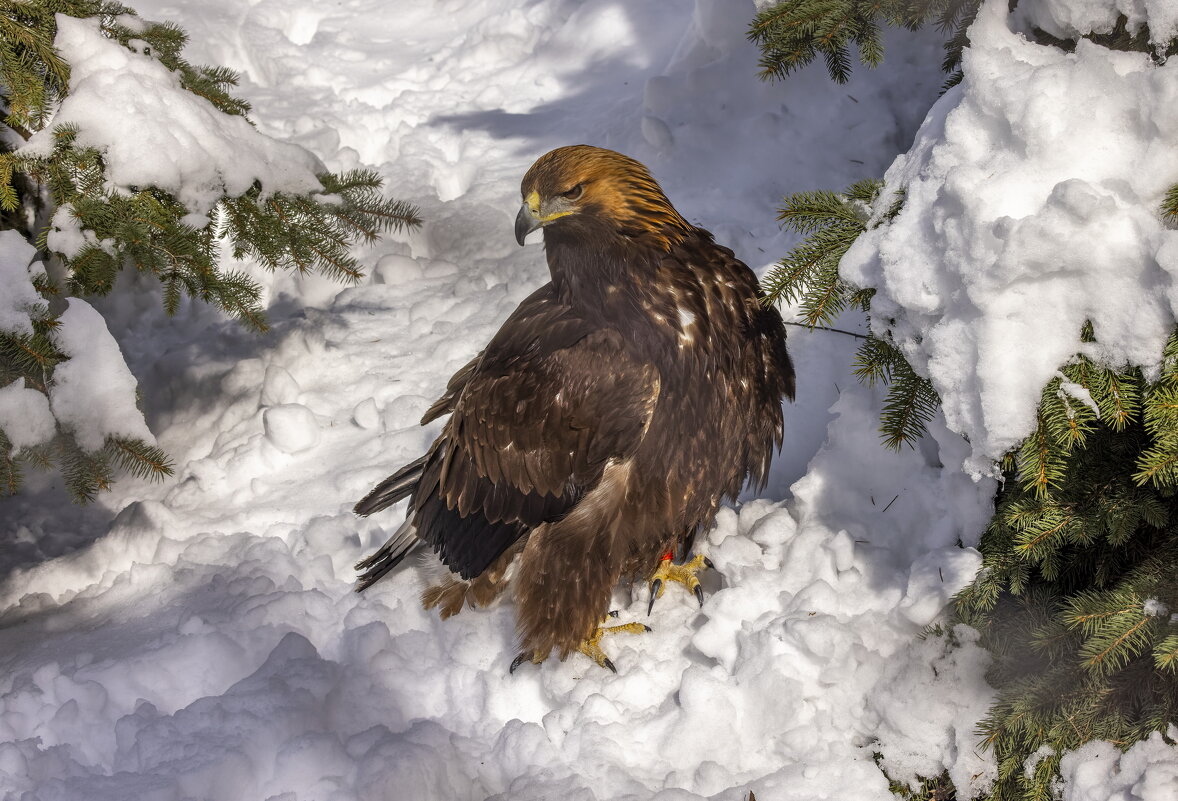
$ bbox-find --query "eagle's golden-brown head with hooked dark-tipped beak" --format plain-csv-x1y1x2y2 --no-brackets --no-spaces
515,145,695,247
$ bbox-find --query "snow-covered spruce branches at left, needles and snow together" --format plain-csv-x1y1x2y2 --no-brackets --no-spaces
0,0,421,501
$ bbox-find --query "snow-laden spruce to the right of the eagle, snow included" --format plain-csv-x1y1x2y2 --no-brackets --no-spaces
753,1,1178,801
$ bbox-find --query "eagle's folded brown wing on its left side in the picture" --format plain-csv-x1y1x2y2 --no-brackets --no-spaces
413,287,659,578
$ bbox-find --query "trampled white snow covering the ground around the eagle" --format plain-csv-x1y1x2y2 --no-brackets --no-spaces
0,0,1178,801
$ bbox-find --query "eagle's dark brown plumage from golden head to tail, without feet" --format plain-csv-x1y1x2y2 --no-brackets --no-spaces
356,145,794,658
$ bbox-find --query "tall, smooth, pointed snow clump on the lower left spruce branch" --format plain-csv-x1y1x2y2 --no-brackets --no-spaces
49,298,155,451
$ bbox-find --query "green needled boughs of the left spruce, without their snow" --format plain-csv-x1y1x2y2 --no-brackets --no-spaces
0,0,421,502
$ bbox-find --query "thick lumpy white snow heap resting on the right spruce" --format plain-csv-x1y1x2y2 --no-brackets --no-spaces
841,0,1178,475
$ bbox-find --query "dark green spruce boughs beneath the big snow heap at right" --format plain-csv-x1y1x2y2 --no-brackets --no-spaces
954,337,1178,801
